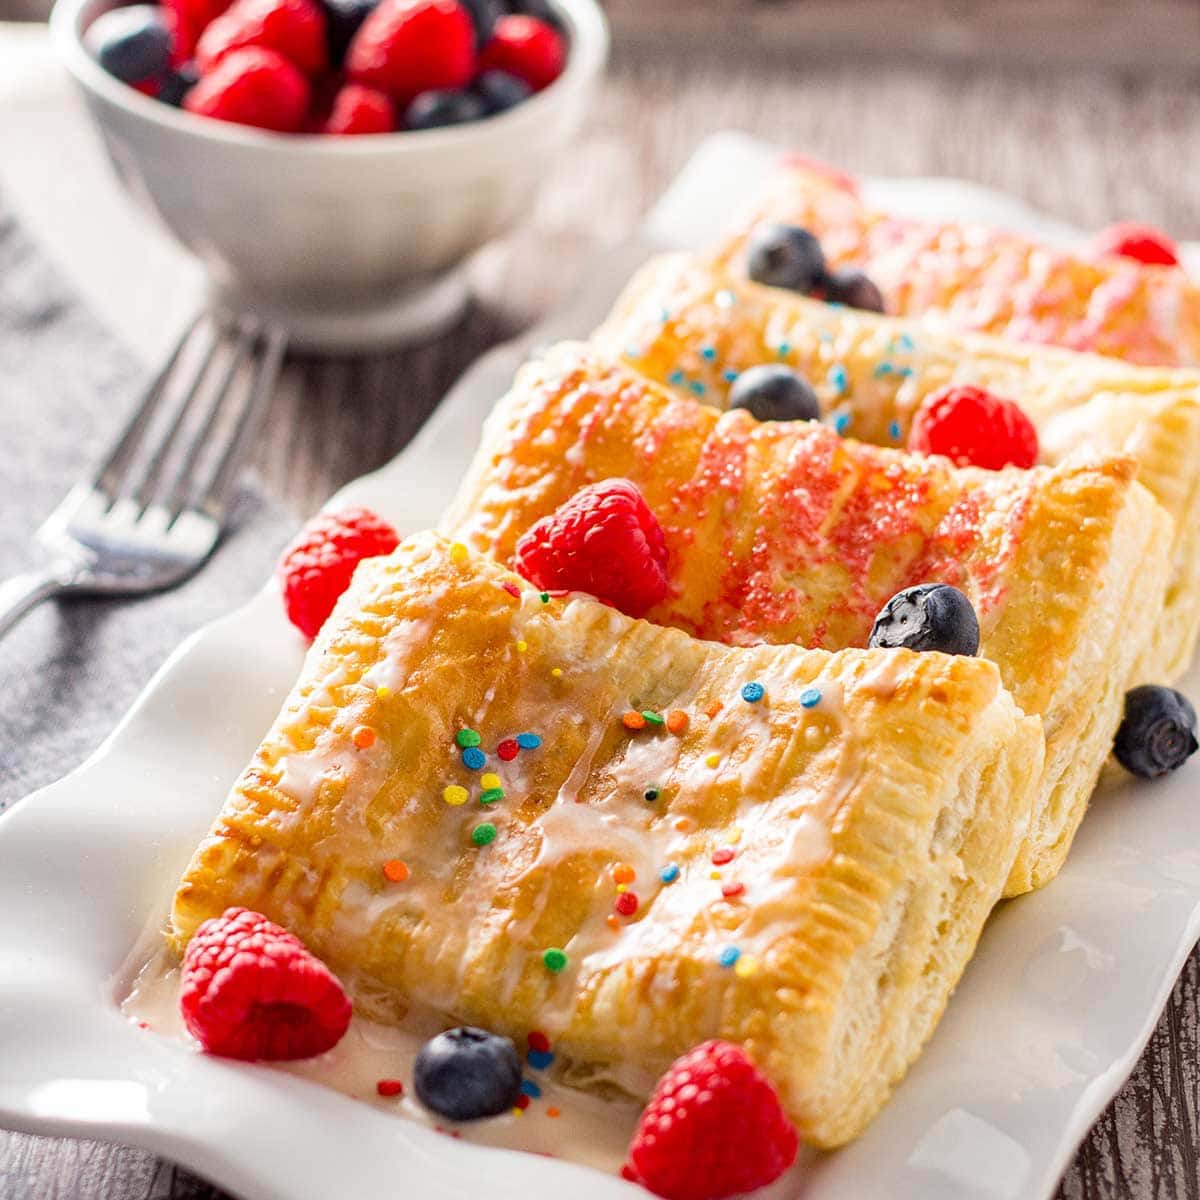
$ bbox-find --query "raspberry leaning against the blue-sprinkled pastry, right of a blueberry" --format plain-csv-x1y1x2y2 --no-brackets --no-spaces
908,384,1038,470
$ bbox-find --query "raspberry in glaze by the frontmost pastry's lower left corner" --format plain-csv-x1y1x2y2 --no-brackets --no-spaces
179,908,350,1061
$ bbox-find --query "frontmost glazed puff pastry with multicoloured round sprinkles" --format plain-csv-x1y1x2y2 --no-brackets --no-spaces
169,534,1042,1146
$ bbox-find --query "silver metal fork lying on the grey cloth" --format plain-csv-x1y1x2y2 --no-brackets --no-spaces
0,312,286,636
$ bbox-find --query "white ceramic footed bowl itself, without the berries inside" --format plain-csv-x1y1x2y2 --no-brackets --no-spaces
50,0,608,349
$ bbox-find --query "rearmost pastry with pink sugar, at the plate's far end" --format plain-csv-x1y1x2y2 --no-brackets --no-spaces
718,162,1200,366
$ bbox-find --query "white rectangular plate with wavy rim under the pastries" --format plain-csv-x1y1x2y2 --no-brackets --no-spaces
0,136,1200,1200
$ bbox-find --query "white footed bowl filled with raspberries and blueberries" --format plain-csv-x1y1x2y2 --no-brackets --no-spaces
52,0,608,350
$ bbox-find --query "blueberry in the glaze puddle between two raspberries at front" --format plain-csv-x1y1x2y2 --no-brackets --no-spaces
413,1025,521,1121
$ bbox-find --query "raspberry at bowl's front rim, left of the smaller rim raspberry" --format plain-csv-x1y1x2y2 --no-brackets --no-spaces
184,46,308,133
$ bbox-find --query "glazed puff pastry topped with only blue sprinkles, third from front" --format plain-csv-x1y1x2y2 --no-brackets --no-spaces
595,256,1200,683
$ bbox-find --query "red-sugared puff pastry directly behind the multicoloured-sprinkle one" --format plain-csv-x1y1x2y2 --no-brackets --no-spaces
444,346,1170,894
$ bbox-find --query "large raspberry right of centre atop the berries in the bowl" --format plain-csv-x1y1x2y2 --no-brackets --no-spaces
346,0,475,104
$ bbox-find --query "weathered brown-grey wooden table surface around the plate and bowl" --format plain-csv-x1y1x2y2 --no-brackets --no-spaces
0,25,1200,1200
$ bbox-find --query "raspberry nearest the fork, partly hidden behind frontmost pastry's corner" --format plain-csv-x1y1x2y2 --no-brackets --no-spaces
278,509,400,637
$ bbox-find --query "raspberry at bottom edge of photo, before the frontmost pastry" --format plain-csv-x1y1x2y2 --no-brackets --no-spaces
623,1042,799,1200
